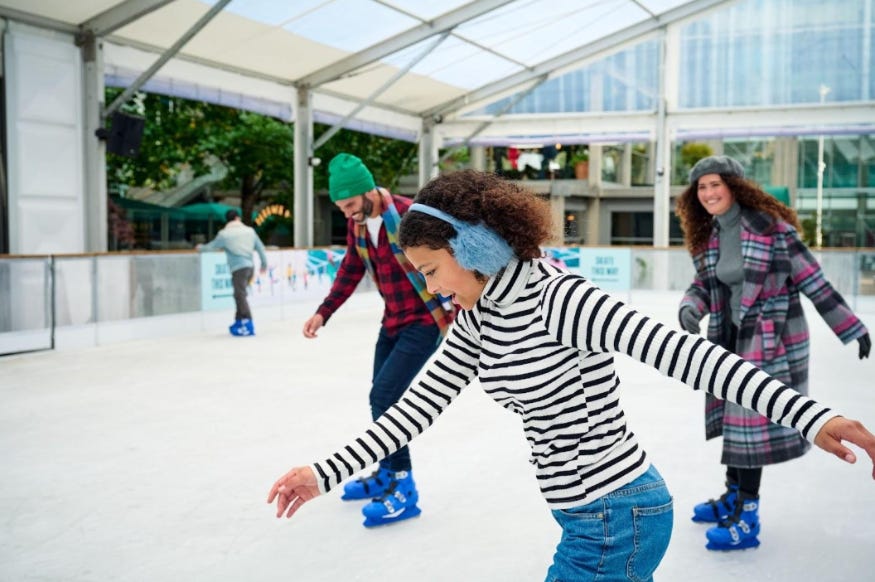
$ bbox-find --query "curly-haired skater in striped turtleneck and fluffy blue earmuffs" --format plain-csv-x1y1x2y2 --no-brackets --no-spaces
268,170,875,582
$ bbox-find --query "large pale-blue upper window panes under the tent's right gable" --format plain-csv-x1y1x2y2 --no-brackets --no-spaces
480,0,875,114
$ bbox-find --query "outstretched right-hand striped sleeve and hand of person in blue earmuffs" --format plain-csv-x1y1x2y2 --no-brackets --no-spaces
542,275,875,476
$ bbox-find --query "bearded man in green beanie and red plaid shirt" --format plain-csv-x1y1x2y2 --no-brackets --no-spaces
304,153,453,527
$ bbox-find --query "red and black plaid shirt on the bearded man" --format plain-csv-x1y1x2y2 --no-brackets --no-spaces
316,194,436,334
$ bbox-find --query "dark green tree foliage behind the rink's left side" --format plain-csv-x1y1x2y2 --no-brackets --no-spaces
106,88,418,220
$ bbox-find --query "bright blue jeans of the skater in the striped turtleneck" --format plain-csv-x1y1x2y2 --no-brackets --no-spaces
546,465,674,582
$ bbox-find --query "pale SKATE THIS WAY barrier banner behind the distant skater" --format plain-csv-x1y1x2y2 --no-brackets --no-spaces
201,248,346,310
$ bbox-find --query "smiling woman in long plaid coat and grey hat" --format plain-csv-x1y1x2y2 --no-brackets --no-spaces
677,156,871,550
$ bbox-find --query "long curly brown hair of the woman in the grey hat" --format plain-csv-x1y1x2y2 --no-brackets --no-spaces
675,174,802,255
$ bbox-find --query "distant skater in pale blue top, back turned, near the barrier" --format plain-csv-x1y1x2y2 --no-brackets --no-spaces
196,210,267,337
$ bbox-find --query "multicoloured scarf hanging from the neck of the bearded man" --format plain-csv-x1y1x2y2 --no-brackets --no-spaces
355,190,453,335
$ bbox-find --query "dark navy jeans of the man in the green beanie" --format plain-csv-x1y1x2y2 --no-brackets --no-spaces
370,325,441,471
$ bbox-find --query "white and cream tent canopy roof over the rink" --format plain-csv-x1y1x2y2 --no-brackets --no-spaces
0,0,727,140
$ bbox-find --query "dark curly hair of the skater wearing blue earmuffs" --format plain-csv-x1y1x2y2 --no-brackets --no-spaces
398,170,553,260
